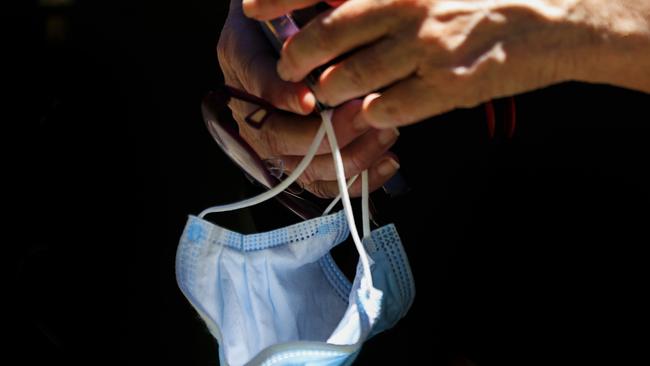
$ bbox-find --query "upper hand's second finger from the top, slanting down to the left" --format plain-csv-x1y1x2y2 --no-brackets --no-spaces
278,0,403,81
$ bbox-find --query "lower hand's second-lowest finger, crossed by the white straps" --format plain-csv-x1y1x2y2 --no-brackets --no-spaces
282,128,399,184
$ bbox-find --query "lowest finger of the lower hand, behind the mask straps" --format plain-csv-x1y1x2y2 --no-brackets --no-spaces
305,154,400,198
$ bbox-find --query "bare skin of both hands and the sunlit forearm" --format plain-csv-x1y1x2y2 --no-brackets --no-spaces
218,0,650,197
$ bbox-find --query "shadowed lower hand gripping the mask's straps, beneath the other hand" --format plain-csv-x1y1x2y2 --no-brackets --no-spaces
217,0,399,198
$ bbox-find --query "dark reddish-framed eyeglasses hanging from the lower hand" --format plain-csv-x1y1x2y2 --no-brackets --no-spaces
202,85,515,220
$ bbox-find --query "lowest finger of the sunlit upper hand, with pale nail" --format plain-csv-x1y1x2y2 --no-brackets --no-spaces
360,77,459,128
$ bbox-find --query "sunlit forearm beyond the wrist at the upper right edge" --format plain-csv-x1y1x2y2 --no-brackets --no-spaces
570,0,650,93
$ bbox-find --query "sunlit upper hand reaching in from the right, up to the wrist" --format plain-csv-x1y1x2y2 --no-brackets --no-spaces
244,0,590,128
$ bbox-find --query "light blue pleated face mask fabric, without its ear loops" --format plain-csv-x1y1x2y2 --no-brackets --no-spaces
176,211,415,366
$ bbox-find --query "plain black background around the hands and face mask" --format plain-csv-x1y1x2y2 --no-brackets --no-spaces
20,0,650,365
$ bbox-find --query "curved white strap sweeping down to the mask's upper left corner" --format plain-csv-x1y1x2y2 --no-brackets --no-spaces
199,124,325,218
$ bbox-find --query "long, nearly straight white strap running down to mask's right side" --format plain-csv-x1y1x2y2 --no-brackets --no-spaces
321,109,374,288
